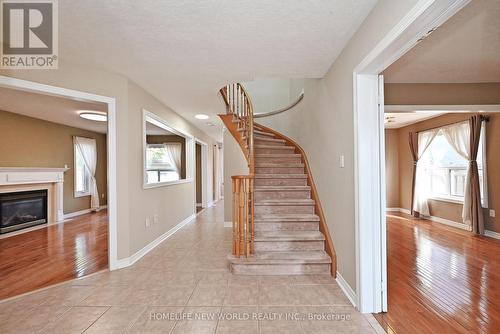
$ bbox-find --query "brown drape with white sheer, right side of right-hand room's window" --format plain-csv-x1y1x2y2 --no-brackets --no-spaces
443,115,484,234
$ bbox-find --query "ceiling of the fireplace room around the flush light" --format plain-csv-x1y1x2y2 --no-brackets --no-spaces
0,87,107,133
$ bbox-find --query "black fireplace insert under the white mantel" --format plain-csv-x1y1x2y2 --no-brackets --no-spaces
0,190,47,234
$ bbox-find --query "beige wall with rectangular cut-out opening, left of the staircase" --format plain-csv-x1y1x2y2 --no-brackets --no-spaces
0,60,215,259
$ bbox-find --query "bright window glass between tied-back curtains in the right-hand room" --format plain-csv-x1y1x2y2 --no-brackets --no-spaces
420,124,488,207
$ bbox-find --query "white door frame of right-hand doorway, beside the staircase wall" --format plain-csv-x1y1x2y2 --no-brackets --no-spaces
353,0,470,313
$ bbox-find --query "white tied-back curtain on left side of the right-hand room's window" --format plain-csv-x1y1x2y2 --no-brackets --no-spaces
412,129,439,216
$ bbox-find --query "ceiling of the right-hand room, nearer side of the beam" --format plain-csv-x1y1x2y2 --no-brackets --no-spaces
383,0,500,83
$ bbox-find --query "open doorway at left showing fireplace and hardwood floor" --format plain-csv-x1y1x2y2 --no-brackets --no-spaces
0,84,110,299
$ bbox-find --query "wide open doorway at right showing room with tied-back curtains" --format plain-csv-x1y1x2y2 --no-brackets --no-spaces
376,1,500,333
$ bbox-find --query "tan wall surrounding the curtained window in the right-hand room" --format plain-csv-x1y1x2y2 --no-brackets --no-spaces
386,114,500,232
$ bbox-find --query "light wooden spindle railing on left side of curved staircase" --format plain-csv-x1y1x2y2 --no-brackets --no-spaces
219,83,255,257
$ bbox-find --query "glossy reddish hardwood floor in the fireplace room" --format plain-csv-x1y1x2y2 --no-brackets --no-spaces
0,210,108,300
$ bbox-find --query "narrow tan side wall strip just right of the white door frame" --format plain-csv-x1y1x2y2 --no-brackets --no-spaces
385,129,399,208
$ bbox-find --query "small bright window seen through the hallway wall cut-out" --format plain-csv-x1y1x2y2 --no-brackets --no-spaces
146,143,181,183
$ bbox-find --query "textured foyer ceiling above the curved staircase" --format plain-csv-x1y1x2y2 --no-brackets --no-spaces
59,0,377,139
